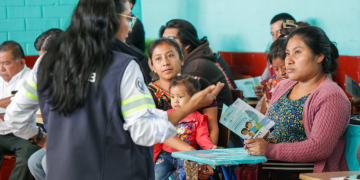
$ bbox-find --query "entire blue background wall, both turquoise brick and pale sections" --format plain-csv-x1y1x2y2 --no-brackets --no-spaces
0,0,360,56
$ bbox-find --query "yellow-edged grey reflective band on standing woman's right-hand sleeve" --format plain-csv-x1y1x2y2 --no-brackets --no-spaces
121,95,155,116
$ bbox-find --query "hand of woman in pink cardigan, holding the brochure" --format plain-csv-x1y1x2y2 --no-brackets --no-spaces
244,138,267,156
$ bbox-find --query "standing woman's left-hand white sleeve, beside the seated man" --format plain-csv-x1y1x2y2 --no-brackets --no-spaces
4,55,43,139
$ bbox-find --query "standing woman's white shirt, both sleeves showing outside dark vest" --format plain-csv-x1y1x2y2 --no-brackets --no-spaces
5,56,176,146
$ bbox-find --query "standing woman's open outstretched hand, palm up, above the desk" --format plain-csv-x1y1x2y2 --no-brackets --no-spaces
187,82,225,110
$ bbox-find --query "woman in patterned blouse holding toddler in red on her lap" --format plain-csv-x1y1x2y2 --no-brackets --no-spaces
148,38,219,177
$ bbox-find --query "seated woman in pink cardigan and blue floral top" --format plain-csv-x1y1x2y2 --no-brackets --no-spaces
244,26,350,173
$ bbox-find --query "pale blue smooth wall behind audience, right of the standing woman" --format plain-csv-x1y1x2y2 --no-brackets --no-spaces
141,0,360,56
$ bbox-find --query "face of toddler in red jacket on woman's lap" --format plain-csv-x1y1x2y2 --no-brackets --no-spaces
170,84,191,109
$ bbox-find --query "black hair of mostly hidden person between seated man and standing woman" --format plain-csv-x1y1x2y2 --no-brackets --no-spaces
34,28,64,51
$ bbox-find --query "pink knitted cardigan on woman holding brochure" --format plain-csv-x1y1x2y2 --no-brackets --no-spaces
265,78,351,173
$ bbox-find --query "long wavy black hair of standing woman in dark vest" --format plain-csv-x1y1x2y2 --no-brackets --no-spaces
37,0,127,116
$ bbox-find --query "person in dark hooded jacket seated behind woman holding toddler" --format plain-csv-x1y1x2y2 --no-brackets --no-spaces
160,19,232,107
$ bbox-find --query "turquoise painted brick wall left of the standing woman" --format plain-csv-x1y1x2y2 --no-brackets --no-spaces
0,0,78,55
